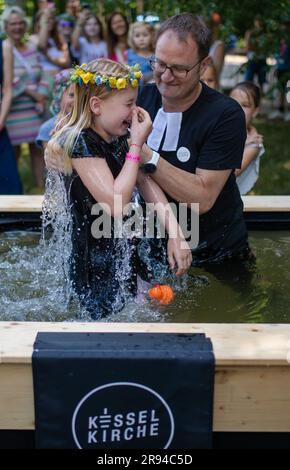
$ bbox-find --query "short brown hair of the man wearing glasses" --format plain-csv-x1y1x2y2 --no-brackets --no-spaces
156,13,211,60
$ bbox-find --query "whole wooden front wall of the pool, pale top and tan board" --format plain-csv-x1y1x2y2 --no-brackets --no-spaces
0,322,290,432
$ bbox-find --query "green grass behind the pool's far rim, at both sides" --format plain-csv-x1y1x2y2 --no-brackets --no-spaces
19,118,290,195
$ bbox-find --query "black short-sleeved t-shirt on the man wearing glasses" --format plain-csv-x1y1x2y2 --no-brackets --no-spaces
138,83,247,264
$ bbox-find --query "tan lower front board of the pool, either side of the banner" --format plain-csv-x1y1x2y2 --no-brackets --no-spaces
0,364,290,432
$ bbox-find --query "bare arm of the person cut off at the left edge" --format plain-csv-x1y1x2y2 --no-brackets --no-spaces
0,40,13,131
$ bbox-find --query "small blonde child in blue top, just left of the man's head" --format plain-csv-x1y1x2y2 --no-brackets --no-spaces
128,22,154,83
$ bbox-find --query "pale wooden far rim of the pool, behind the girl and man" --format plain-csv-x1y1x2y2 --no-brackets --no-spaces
0,196,290,213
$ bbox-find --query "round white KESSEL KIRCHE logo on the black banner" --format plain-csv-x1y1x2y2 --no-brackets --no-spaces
72,382,174,449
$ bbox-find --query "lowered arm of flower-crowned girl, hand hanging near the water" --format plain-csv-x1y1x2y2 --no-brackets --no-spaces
138,171,192,276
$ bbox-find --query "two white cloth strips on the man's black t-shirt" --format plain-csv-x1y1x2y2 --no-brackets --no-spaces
147,108,182,152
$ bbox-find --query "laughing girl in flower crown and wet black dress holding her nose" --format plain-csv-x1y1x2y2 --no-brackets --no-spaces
48,59,191,318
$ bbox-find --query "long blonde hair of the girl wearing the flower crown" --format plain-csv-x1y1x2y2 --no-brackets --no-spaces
48,59,134,174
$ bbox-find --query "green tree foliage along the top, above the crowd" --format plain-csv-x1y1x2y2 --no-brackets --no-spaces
0,0,290,41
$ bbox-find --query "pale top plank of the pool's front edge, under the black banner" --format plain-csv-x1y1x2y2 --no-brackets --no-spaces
0,322,290,366
